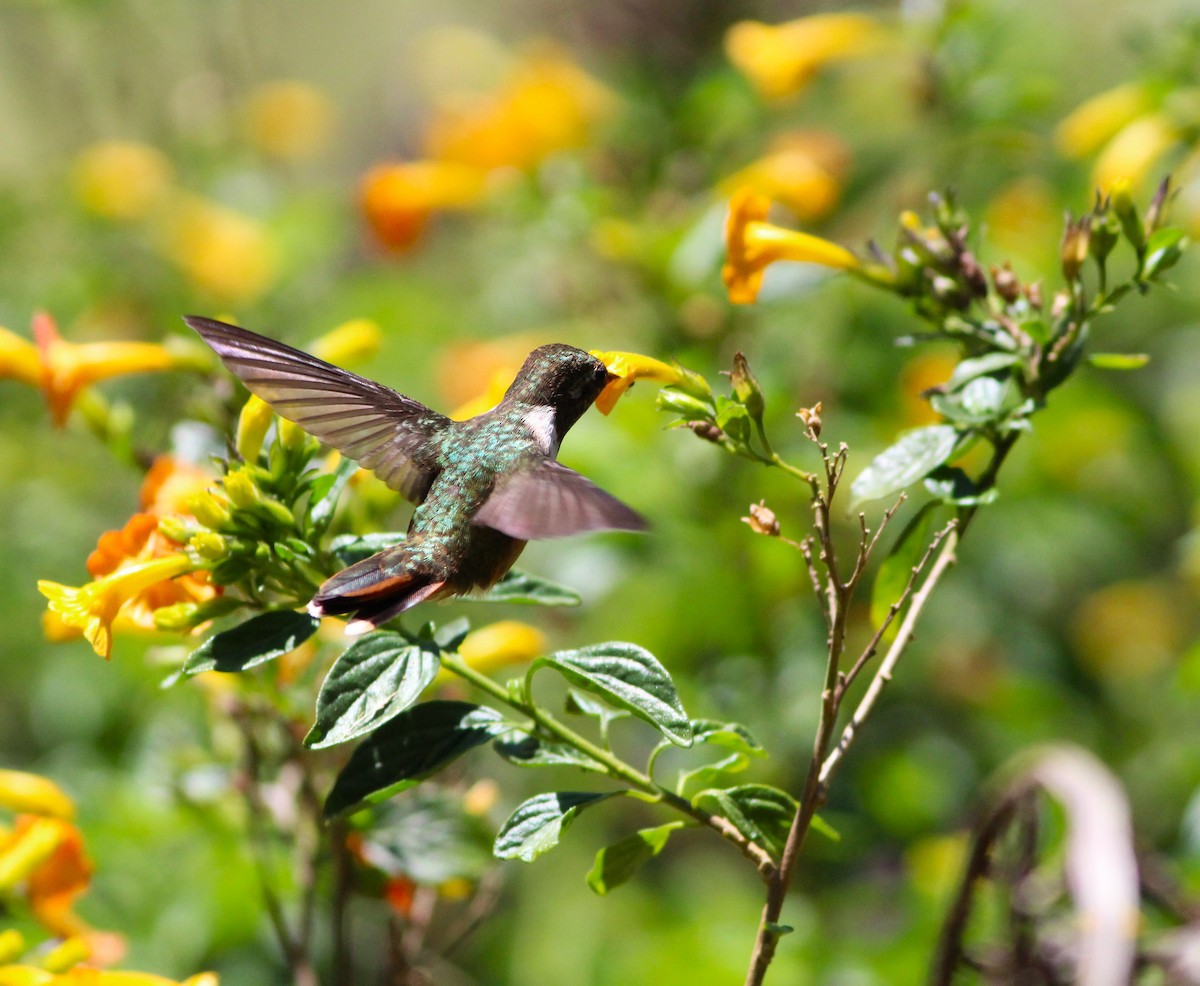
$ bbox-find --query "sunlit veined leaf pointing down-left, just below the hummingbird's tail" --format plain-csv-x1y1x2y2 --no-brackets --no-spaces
305,630,440,750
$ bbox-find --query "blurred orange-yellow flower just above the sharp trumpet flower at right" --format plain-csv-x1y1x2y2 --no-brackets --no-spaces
719,131,850,222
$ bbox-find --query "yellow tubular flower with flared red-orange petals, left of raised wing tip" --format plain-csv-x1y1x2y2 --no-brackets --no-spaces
29,312,178,427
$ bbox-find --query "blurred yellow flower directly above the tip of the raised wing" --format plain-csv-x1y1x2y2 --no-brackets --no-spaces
163,196,278,303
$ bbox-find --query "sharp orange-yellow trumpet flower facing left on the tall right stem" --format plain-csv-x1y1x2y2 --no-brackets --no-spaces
721,188,859,305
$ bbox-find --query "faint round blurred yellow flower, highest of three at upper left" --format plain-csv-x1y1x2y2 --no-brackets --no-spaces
242,79,334,161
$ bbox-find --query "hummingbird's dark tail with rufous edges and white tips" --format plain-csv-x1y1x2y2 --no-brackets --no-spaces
308,548,446,635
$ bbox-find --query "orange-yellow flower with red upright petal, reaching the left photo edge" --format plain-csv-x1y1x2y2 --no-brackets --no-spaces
7,312,184,427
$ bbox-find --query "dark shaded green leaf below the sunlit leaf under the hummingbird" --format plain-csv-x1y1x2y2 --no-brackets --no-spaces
325,702,510,818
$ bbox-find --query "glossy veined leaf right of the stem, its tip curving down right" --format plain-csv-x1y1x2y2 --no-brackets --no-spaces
533,642,691,746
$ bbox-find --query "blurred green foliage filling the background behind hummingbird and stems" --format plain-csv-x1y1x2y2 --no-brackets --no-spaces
0,0,1200,986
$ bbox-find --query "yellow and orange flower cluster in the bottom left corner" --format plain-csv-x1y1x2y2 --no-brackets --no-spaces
0,770,217,986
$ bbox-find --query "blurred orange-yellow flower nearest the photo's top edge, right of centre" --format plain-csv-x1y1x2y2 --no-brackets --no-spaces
725,13,887,100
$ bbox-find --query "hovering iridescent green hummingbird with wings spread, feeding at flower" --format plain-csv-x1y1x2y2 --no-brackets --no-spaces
184,315,647,635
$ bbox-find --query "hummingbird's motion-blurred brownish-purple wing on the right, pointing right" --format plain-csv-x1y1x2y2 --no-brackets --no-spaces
472,458,647,541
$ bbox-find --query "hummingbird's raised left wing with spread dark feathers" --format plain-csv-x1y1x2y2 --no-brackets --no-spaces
184,315,450,504
